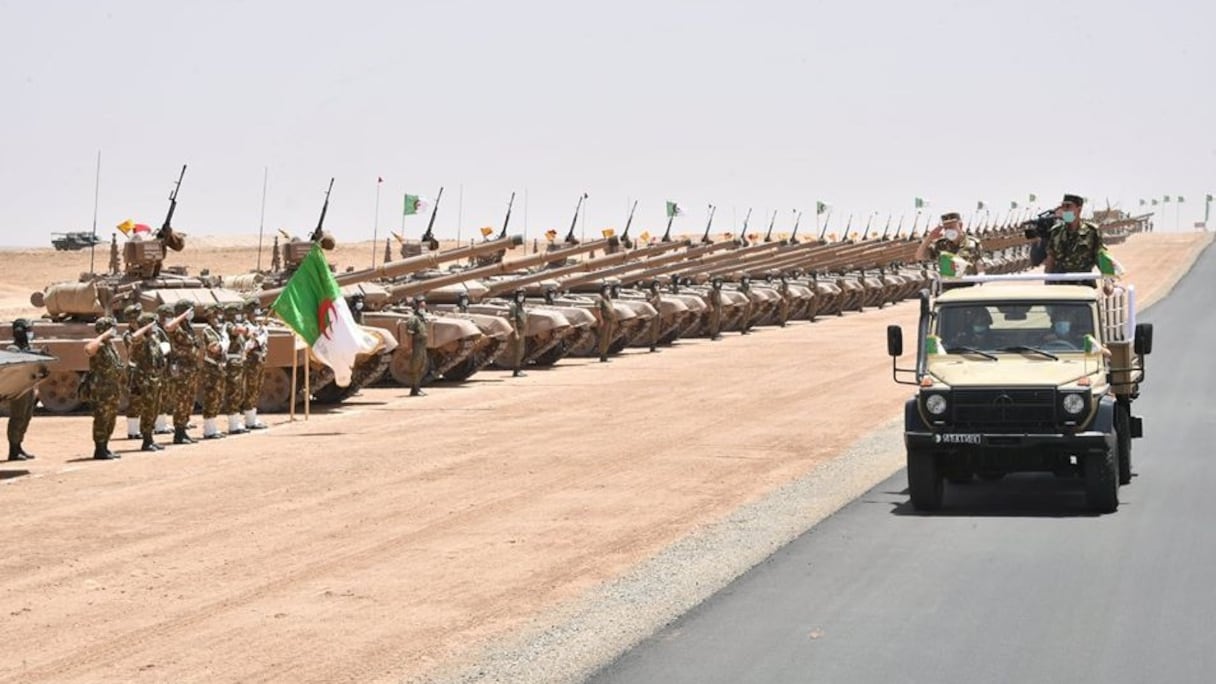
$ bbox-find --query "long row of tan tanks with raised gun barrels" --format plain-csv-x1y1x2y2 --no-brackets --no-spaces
4,167,1144,413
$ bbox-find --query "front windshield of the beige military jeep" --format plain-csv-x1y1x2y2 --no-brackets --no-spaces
934,301,1096,350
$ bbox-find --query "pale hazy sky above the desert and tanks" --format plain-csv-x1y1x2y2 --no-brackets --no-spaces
0,0,1216,245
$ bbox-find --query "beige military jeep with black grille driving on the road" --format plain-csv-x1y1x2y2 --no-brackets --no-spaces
886,274,1153,512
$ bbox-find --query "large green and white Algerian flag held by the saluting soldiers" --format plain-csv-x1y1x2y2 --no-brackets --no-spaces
270,245,381,387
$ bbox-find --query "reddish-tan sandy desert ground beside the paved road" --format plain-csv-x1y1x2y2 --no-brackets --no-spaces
0,235,1209,682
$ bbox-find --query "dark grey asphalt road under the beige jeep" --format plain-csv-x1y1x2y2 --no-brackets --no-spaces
591,244,1216,684
